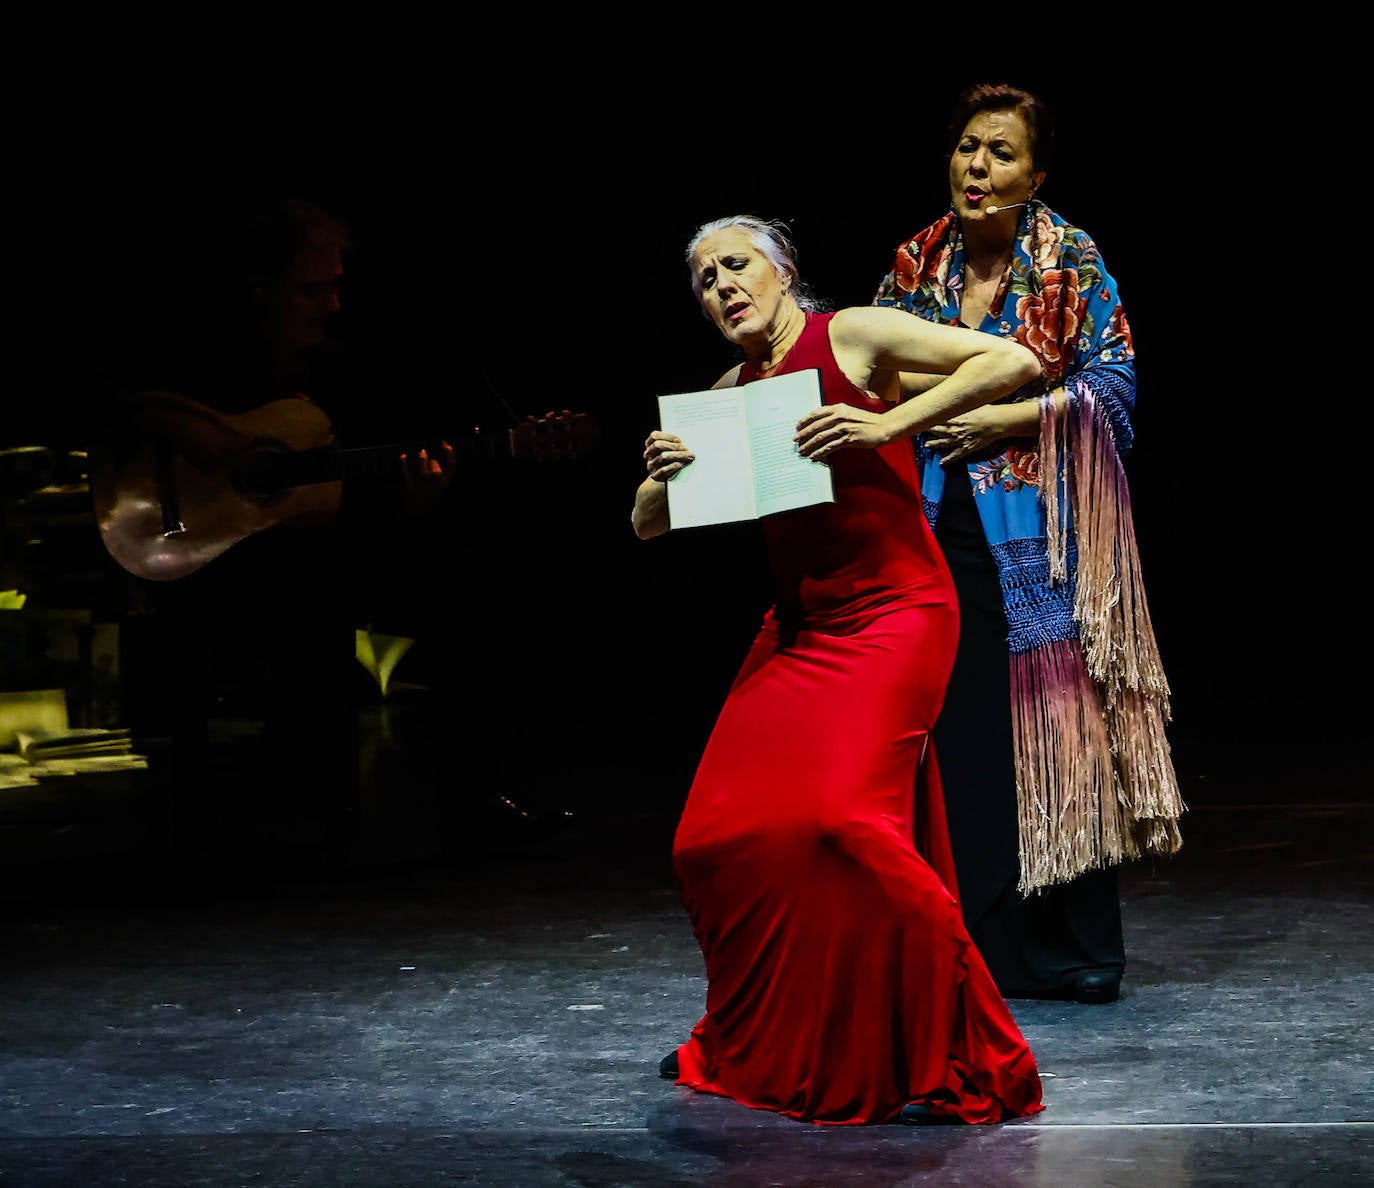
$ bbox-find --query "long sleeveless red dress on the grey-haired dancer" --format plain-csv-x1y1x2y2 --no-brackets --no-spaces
673,313,1044,1123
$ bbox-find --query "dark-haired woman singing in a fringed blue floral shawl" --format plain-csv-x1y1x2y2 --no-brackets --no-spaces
874,85,1184,1003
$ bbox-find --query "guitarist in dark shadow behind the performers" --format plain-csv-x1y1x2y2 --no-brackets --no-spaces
91,192,453,863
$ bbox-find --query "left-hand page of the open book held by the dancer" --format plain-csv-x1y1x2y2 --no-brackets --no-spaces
658,387,758,529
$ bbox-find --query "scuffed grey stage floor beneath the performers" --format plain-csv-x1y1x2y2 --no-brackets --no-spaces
0,719,1374,1188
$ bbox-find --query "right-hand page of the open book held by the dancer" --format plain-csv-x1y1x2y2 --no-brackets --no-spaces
745,368,835,515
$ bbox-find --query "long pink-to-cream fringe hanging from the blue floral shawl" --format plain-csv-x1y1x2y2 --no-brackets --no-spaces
1011,382,1184,894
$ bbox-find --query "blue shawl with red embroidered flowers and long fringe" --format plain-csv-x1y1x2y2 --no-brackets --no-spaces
874,201,1184,891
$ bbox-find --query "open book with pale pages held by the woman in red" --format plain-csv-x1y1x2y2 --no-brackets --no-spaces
658,367,835,529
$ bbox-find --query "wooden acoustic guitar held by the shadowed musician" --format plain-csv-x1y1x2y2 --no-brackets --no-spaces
89,391,598,581
